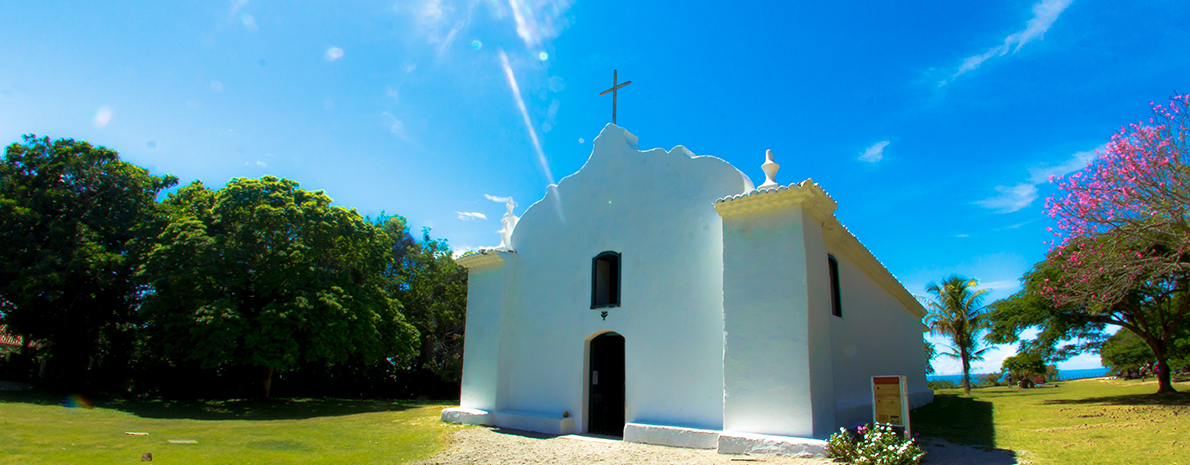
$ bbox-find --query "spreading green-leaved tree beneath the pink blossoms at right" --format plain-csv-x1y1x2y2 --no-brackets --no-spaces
988,236,1190,392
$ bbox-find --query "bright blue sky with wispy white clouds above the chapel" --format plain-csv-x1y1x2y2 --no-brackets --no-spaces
0,0,1190,372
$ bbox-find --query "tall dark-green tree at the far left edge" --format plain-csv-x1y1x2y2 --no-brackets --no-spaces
0,136,177,379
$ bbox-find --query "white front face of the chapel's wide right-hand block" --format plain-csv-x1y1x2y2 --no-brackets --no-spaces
724,205,815,438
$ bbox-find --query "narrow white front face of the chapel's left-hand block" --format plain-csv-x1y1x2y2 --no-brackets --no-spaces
459,264,505,411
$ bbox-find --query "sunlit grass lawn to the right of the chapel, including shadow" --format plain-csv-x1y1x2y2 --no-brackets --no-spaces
910,379,1190,465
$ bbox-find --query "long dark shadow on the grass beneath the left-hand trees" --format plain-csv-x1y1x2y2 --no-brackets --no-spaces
0,390,445,421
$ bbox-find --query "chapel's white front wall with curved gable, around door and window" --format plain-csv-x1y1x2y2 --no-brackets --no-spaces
463,125,751,431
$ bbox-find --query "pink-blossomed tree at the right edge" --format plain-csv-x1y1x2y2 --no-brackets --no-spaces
1042,95,1190,392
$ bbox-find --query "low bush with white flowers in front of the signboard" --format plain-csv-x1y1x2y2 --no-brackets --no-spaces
826,423,926,465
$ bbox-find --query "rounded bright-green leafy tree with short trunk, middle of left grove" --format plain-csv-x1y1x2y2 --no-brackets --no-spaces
144,176,418,397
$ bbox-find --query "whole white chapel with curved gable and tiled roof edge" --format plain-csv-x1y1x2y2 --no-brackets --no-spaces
441,125,933,454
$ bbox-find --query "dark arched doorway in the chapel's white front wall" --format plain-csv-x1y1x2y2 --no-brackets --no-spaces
587,333,624,436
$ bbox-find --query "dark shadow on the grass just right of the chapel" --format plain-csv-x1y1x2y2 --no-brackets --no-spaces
909,394,996,447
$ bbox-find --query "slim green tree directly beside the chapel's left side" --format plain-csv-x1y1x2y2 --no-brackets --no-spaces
376,215,468,394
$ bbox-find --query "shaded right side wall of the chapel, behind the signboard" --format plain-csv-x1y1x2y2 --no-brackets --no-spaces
828,247,933,427
